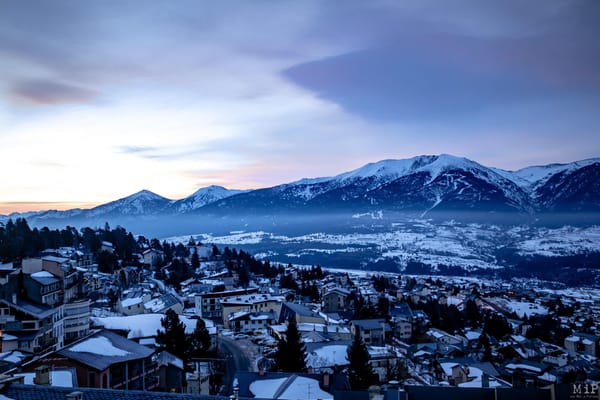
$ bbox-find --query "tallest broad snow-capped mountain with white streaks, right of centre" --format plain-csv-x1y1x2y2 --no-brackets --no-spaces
208,154,533,212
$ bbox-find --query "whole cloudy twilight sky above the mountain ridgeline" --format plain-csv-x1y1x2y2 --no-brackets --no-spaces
0,0,600,214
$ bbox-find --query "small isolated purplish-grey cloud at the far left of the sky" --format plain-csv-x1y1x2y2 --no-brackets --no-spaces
10,80,98,105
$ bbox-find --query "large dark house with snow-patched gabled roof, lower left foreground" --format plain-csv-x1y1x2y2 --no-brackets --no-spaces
28,330,158,390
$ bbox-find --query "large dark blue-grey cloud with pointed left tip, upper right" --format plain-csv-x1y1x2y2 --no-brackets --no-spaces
283,1,600,122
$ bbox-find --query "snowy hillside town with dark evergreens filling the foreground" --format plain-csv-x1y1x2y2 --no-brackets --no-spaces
0,219,600,399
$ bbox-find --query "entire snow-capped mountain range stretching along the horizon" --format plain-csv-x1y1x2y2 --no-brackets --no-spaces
0,154,600,231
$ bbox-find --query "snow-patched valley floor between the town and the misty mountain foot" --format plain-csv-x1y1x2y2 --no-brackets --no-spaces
166,218,600,271
